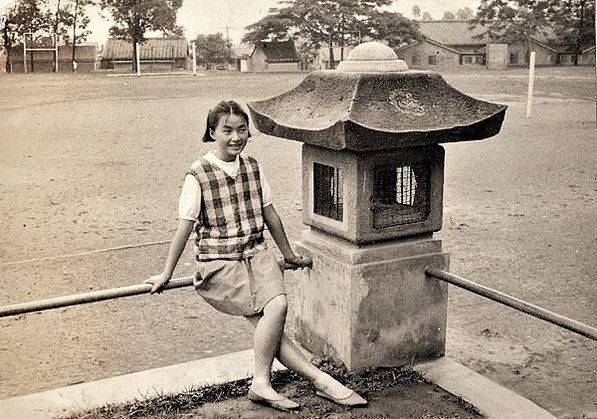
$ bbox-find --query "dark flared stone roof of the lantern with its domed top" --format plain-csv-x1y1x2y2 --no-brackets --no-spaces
248,43,506,151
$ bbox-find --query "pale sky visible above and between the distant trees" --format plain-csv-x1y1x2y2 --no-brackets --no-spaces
0,0,480,44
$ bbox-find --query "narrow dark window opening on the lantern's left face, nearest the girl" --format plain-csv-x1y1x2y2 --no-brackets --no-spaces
313,162,344,221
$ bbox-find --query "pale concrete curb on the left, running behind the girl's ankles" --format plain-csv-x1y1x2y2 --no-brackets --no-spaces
0,349,285,419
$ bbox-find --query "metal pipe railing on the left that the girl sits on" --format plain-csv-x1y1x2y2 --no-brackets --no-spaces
0,258,313,318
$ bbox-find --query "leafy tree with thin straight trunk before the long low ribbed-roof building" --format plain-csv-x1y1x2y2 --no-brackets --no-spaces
100,0,183,71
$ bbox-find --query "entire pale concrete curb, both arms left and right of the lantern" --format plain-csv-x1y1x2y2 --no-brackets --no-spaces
0,349,555,419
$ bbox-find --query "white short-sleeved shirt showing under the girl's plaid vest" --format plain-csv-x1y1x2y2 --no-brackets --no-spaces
178,151,272,221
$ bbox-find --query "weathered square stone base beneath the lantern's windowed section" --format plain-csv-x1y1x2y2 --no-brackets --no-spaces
293,229,449,370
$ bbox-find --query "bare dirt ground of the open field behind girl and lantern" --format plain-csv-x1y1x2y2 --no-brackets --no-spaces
0,67,597,418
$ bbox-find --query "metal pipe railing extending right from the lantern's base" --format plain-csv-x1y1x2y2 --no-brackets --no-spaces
425,267,597,340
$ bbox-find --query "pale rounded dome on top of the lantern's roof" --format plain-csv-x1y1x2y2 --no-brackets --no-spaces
338,41,408,73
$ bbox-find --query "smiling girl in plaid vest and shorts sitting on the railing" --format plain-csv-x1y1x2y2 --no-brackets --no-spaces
145,101,367,410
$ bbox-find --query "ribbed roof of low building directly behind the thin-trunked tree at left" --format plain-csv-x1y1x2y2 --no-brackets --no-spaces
103,38,188,60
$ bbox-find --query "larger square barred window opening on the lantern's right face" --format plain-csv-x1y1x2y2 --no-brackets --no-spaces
371,163,431,229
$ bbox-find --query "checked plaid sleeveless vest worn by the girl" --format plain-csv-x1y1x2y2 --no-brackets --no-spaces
189,156,267,261
